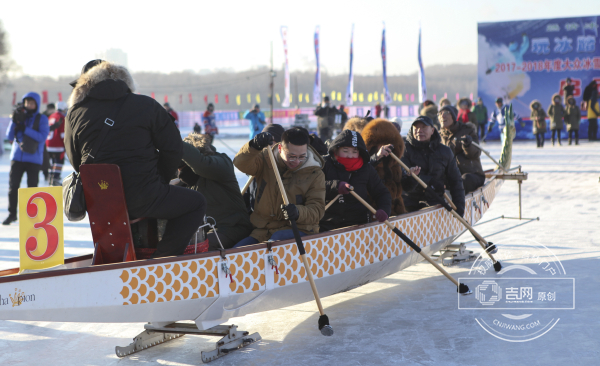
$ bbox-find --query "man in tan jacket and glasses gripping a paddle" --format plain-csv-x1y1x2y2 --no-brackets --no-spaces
233,127,325,247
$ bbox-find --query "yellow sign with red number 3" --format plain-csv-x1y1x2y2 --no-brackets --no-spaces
19,187,65,271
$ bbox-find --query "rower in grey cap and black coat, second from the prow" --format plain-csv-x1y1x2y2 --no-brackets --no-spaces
401,116,465,216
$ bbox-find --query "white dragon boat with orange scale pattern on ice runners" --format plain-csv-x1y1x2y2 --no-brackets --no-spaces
0,112,514,362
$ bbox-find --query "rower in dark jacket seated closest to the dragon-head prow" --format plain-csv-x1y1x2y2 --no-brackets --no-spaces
438,106,485,194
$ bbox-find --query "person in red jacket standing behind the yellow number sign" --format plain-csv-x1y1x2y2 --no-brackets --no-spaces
46,102,67,186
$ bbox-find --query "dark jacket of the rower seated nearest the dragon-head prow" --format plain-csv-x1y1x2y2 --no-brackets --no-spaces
440,121,485,177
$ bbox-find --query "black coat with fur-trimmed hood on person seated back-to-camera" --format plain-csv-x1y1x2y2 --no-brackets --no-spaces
65,62,183,217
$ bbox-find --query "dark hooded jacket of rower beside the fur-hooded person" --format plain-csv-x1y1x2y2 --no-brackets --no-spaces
179,134,252,237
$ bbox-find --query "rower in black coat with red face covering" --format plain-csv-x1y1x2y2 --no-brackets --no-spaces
319,130,392,232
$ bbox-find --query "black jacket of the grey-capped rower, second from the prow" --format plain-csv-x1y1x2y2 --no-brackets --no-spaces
402,127,465,216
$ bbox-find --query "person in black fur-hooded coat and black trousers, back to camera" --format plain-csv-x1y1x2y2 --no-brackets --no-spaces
65,60,206,257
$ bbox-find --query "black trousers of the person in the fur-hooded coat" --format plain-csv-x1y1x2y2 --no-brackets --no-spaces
141,186,206,258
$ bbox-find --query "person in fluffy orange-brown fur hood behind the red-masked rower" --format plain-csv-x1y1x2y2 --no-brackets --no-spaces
361,118,408,216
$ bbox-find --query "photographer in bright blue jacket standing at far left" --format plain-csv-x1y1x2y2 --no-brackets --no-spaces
2,92,49,225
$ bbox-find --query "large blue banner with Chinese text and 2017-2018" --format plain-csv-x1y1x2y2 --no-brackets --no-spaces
477,16,600,139
